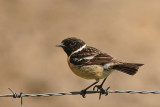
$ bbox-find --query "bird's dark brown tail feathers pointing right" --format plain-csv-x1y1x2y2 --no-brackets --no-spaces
113,63,144,75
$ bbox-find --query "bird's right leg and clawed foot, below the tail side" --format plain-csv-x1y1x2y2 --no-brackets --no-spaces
93,78,110,99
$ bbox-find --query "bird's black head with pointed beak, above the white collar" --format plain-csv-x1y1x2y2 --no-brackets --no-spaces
56,37,85,56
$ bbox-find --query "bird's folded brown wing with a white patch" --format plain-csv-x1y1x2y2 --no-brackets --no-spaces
70,46,113,65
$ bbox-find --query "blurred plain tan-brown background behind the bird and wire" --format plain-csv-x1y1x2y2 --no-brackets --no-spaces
0,0,160,107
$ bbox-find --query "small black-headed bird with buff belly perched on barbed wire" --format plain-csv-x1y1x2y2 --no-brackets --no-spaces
56,37,144,99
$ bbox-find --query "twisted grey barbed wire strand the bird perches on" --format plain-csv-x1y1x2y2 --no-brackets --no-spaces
0,88,160,105
